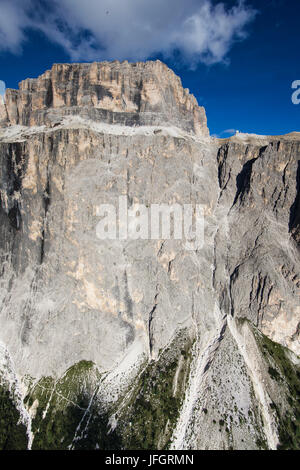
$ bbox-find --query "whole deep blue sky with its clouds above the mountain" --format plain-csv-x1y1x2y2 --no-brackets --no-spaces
0,0,300,137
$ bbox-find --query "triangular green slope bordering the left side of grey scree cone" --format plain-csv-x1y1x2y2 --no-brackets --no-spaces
116,334,191,449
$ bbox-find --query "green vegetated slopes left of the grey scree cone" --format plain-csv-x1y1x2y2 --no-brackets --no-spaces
0,334,192,450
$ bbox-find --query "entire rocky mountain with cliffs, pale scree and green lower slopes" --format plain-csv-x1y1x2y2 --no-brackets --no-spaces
0,62,300,449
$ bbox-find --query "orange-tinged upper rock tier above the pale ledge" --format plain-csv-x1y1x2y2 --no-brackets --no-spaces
0,61,208,135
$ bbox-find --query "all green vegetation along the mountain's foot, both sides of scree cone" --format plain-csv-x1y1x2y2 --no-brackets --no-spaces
0,327,300,450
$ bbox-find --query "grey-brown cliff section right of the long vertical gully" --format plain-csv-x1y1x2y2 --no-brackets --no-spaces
216,134,300,354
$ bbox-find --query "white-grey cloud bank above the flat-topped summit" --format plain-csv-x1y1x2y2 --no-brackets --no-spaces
0,0,256,67
